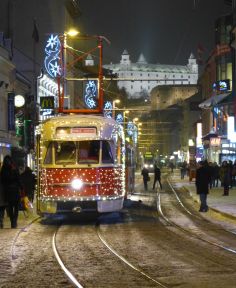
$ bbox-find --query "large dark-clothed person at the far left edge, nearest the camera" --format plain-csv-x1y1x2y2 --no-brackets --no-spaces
0,155,22,228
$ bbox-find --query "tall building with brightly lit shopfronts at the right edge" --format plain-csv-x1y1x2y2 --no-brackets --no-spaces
199,14,236,163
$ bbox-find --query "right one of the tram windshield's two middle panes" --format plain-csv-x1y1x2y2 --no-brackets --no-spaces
78,140,100,164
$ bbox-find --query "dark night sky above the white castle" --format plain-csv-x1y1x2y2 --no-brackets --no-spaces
79,0,231,64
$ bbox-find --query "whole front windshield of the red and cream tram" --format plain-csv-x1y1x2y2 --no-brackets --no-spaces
44,140,114,165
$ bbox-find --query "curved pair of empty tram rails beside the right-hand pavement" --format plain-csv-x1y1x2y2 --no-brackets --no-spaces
157,180,236,254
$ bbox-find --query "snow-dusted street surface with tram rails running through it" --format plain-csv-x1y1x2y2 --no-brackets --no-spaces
0,173,236,288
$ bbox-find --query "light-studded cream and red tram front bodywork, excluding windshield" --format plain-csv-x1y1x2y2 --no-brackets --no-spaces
37,115,125,202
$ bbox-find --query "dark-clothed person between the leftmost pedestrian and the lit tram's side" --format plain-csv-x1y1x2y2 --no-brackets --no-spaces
20,166,36,203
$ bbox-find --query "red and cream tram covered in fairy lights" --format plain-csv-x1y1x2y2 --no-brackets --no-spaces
37,115,128,214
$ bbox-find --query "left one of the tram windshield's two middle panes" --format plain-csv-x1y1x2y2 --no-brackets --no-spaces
54,141,76,164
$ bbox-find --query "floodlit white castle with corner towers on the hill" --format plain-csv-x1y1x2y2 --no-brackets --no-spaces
104,50,198,98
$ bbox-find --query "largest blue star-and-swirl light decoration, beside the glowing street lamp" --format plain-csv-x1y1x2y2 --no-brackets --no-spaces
44,34,61,78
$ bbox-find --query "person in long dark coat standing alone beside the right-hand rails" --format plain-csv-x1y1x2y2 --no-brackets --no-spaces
196,161,210,212
